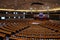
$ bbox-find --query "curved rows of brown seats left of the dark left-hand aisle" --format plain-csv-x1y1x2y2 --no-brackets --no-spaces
0,20,28,37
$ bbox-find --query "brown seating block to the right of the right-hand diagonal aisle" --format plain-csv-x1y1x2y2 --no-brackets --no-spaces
41,21,60,32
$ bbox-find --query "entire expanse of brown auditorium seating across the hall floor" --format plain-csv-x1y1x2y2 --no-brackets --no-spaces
0,20,60,40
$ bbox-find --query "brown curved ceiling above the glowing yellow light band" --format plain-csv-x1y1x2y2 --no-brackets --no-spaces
0,0,60,10
